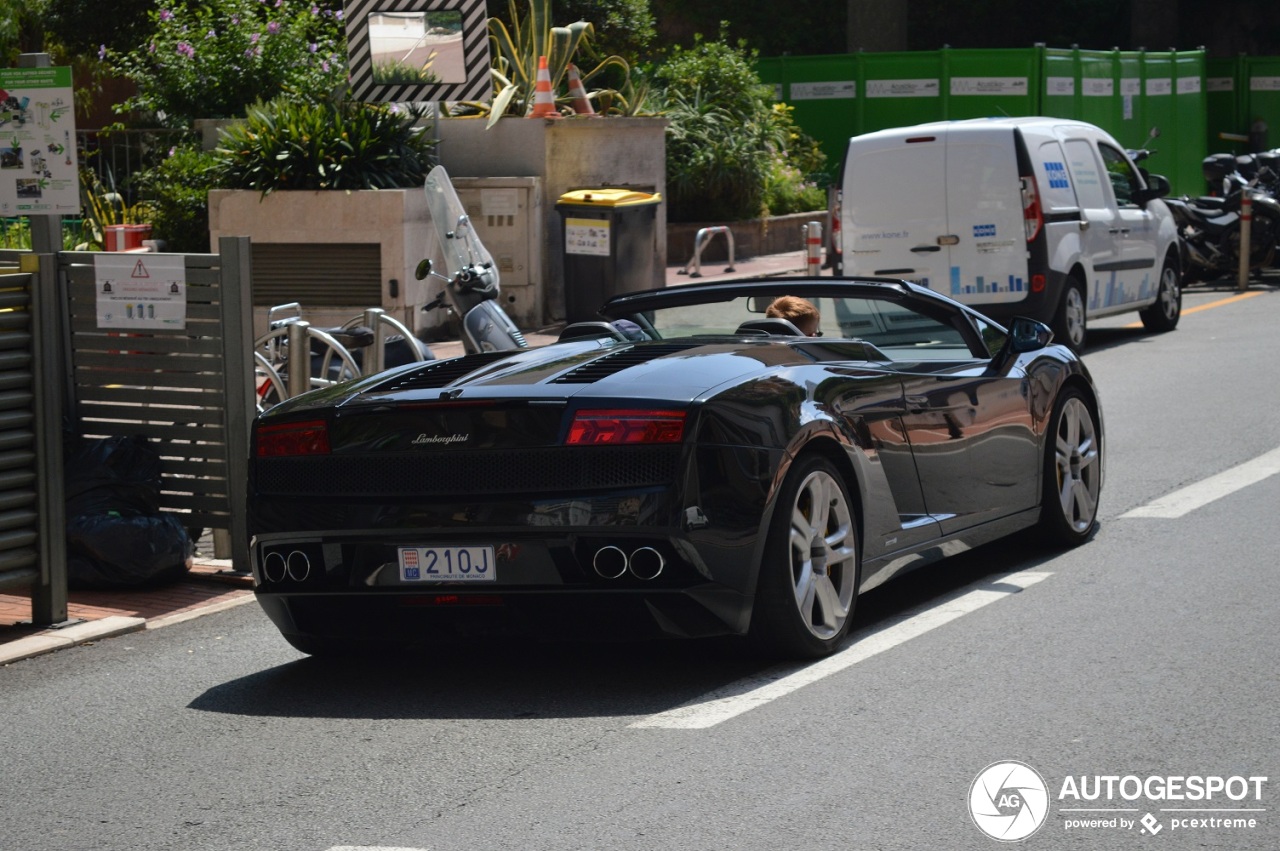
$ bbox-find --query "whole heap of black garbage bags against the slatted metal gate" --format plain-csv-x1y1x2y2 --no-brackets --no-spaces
67,435,196,589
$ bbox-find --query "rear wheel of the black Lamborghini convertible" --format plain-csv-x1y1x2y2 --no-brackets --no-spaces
750,456,861,659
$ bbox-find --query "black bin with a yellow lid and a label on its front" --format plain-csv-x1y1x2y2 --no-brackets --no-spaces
556,188,662,322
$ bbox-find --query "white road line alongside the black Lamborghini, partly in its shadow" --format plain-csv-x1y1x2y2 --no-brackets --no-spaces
630,571,1052,729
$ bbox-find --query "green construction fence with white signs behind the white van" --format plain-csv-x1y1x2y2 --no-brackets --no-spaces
756,46,1280,195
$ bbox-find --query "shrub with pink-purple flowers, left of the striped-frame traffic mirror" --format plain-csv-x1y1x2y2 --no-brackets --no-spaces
102,0,347,127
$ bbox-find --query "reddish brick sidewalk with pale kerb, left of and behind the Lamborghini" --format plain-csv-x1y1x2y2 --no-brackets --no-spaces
0,251,814,665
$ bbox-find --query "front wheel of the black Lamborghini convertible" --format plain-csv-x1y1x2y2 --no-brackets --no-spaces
1039,388,1102,546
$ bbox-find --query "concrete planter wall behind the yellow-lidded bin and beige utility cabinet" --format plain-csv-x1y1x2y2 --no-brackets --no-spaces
429,118,667,322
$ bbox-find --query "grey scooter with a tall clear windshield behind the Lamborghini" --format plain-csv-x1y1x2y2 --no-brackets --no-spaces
415,165,529,354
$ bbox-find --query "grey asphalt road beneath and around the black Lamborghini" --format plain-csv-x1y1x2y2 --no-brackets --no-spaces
0,280,1280,851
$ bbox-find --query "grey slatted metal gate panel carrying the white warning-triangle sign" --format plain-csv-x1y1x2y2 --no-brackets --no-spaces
58,237,255,571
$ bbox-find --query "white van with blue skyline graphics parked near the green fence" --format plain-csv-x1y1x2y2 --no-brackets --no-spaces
840,118,1181,351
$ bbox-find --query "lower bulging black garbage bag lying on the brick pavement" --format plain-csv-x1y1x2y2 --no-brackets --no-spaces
67,512,195,589
